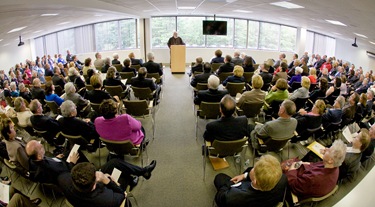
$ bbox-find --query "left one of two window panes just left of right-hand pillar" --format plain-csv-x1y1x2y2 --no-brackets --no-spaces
259,22,280,50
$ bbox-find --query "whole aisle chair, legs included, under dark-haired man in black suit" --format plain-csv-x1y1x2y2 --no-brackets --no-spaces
203,137,248,180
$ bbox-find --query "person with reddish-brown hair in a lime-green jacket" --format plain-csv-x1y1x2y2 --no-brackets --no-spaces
265,78,289,109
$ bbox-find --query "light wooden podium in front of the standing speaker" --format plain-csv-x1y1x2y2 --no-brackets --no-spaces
171,45,186,74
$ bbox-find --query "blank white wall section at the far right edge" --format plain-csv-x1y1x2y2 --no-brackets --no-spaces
336,39,375,71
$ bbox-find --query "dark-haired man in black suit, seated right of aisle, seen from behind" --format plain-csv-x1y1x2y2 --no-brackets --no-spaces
203,95,253,142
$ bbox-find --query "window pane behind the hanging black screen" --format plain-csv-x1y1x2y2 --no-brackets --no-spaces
206,17,234,47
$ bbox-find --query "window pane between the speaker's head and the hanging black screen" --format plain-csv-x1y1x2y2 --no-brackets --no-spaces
177,17,205,47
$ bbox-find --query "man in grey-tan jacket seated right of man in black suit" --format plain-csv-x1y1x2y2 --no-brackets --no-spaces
249,100,297,144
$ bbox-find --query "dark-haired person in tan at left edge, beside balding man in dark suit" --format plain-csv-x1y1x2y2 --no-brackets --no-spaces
1,118,29,172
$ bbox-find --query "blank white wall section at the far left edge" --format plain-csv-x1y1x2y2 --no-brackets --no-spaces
0,40,32,73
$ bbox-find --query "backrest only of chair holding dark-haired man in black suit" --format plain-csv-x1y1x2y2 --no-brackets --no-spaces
209,137,248,157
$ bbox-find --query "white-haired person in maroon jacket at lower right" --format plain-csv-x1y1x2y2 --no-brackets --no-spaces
286,140,346,200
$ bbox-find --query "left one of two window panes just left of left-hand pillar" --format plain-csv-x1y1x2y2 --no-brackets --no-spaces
95,21,120,51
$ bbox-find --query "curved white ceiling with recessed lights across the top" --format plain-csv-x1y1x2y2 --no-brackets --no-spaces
0,0,375,49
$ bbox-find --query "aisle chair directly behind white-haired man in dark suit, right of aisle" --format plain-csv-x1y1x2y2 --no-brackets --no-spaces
195,101,221,139
